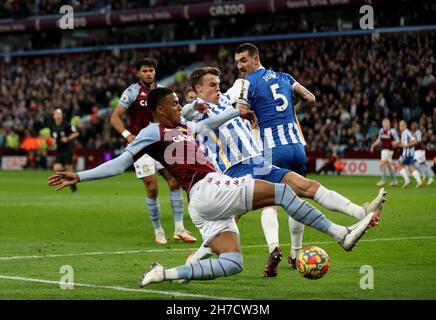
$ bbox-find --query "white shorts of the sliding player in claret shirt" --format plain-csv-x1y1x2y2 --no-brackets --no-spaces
188,172,254,245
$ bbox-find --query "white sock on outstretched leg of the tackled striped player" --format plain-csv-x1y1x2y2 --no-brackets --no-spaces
313,185,366,220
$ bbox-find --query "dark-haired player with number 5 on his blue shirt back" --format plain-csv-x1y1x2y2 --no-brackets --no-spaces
235,43,316,266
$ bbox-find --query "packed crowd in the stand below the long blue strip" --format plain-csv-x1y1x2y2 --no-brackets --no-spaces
0,33,436,160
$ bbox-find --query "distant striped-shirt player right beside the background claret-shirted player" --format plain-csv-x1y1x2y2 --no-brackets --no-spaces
399,120,424,188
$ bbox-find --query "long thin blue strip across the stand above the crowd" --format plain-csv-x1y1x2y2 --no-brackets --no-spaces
0,24,436,58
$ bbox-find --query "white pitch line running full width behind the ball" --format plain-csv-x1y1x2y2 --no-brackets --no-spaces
0,236,436,261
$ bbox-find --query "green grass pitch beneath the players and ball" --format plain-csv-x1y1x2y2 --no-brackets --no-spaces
0,171,436,300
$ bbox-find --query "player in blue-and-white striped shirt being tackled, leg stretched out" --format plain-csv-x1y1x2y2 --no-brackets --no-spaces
182,67,385,277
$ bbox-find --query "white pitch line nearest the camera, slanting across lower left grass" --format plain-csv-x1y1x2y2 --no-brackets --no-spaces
0,275,237,300
